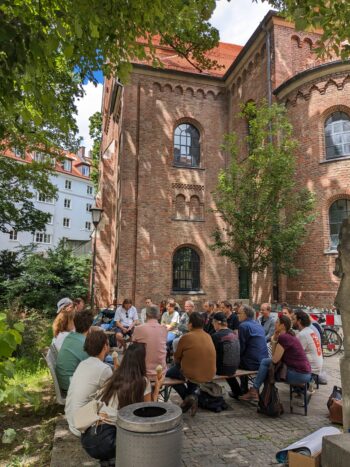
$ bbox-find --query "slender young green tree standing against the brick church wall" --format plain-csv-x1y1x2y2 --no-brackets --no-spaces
212,102,314,300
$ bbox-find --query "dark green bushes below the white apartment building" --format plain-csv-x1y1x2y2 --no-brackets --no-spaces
0,241,90,314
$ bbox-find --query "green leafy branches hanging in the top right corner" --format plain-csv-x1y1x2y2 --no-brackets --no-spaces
262,0,350,59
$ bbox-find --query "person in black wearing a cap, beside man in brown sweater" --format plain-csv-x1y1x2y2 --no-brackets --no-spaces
211,312,240,390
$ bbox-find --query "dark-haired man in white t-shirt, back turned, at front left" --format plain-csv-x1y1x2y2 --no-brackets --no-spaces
65,326,112,436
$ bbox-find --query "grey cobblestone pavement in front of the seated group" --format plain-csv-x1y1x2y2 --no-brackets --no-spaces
176,356,340,467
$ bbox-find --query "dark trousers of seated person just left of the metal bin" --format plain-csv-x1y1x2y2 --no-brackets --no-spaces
81,423,117,461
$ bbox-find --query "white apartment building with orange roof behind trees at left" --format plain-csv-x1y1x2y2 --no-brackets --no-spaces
0,148,94,254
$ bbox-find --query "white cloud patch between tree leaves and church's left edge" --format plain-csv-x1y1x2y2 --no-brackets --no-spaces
75,83,103,151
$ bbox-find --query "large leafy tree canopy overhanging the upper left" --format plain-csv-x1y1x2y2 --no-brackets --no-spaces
0,0,219,230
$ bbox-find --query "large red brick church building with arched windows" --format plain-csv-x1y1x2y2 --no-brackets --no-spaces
96,12,350,308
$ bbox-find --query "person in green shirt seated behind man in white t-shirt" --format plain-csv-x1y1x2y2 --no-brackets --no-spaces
56,311,93,391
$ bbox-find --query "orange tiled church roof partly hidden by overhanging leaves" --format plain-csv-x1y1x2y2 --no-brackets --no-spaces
134,36,243,78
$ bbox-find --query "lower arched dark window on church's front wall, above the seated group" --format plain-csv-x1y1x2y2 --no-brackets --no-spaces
173,247,200,292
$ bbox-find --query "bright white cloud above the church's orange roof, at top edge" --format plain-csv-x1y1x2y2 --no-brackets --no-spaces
210,0,271,45
